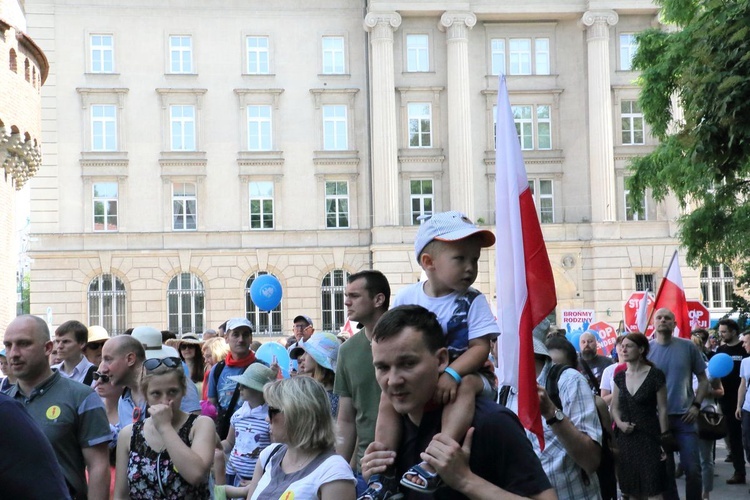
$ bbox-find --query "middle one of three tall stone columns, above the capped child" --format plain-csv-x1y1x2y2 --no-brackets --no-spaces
438,11,477,218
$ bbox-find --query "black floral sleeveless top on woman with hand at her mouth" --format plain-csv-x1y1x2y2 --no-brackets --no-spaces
128,414,210,500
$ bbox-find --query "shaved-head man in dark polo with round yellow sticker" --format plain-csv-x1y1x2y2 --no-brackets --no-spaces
3,315,112,499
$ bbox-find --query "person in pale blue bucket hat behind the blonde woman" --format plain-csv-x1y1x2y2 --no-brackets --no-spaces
289,332,341,418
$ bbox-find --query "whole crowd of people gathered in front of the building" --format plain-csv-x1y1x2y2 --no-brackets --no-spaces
0,212,750,500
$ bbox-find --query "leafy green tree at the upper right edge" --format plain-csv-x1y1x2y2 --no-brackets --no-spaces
628,0,750,314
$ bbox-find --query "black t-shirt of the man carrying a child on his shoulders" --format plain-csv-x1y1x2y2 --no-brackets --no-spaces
396,398,552,500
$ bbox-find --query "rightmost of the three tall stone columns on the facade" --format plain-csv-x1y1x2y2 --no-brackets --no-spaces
581,10,618,222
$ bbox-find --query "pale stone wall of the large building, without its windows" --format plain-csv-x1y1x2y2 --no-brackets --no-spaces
26,0,699,336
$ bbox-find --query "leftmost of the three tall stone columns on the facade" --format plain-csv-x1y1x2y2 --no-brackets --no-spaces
364,12,401,227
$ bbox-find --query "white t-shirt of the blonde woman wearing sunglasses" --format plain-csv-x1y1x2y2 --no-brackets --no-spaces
251,443,356,500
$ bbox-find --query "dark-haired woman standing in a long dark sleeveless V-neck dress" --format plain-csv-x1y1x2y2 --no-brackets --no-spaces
611,333,669,498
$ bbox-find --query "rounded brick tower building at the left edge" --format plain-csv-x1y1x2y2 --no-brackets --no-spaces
0,0,49,332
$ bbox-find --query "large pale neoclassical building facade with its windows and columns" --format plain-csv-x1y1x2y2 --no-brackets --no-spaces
26,0,729,333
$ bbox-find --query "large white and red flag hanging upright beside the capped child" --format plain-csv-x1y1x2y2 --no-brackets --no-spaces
495,75,557,449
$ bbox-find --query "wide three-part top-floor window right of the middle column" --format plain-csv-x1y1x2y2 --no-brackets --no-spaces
490,37,552,75
